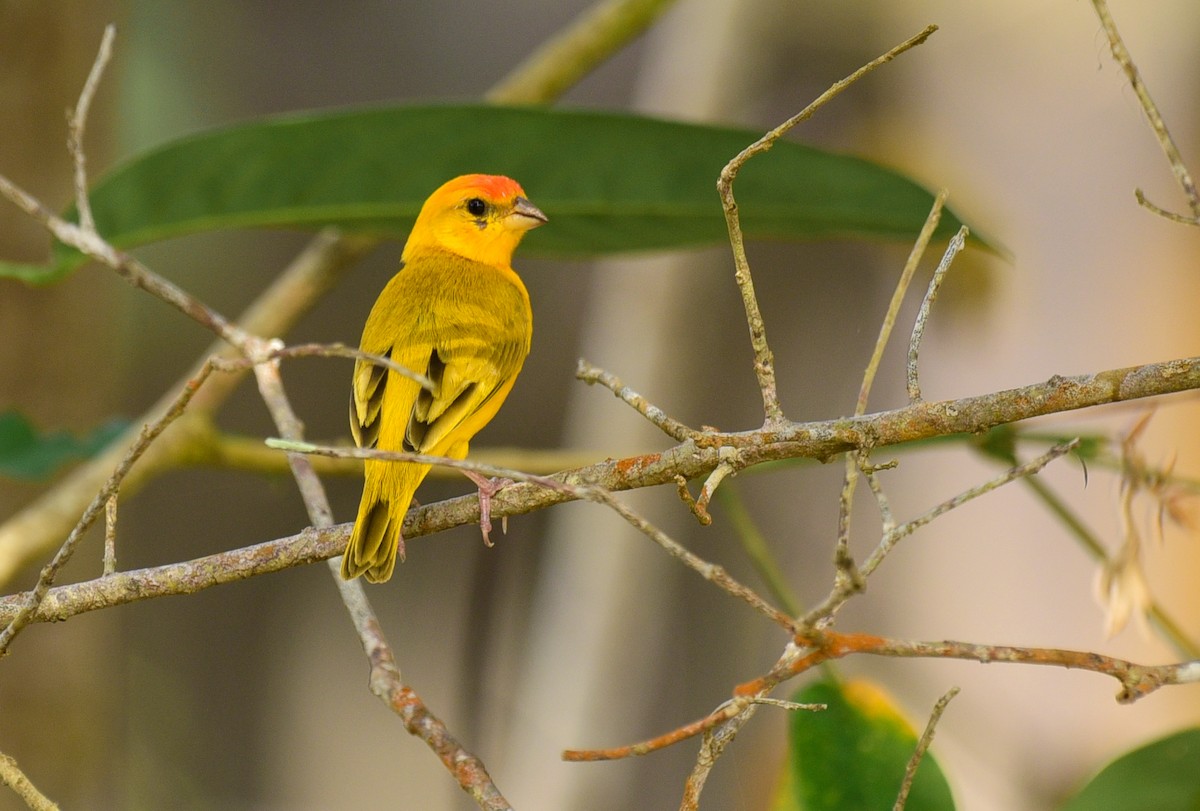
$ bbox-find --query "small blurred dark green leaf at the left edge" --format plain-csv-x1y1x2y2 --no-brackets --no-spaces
0,410,128,480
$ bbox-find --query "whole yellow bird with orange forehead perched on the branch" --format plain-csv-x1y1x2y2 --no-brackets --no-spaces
342,175,546,583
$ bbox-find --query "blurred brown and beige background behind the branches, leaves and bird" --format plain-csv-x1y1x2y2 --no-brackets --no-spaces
0,0,1200,811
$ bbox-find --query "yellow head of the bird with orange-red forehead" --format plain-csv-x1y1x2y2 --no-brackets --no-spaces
403,175,546,266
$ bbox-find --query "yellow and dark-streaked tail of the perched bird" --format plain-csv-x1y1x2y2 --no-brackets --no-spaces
342,459,430,583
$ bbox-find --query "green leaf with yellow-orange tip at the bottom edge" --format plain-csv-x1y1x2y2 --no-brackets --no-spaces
787,680,954,811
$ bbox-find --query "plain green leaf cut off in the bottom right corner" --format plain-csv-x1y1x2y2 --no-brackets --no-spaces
1063,728,1200,811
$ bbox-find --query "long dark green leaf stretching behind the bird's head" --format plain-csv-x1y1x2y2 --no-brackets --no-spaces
0,104,984,282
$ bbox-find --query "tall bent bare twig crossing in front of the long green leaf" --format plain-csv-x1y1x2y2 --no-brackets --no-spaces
716,25,937,426
